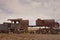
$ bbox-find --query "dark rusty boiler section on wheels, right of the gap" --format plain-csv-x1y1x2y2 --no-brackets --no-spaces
36,19,60,34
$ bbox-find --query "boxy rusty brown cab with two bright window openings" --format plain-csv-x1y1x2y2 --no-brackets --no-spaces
9,19,29,33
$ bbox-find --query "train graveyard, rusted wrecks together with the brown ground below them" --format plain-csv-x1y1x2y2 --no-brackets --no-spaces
0,19,60,40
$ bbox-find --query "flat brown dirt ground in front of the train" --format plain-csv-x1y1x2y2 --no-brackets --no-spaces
0,33,60,40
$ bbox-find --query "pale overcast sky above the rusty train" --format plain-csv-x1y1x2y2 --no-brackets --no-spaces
0,0,60,24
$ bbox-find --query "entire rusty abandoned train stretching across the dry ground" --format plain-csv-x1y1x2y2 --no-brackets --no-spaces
0,19,60,34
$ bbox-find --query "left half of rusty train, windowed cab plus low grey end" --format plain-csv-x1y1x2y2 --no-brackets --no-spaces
0,19,29,33
